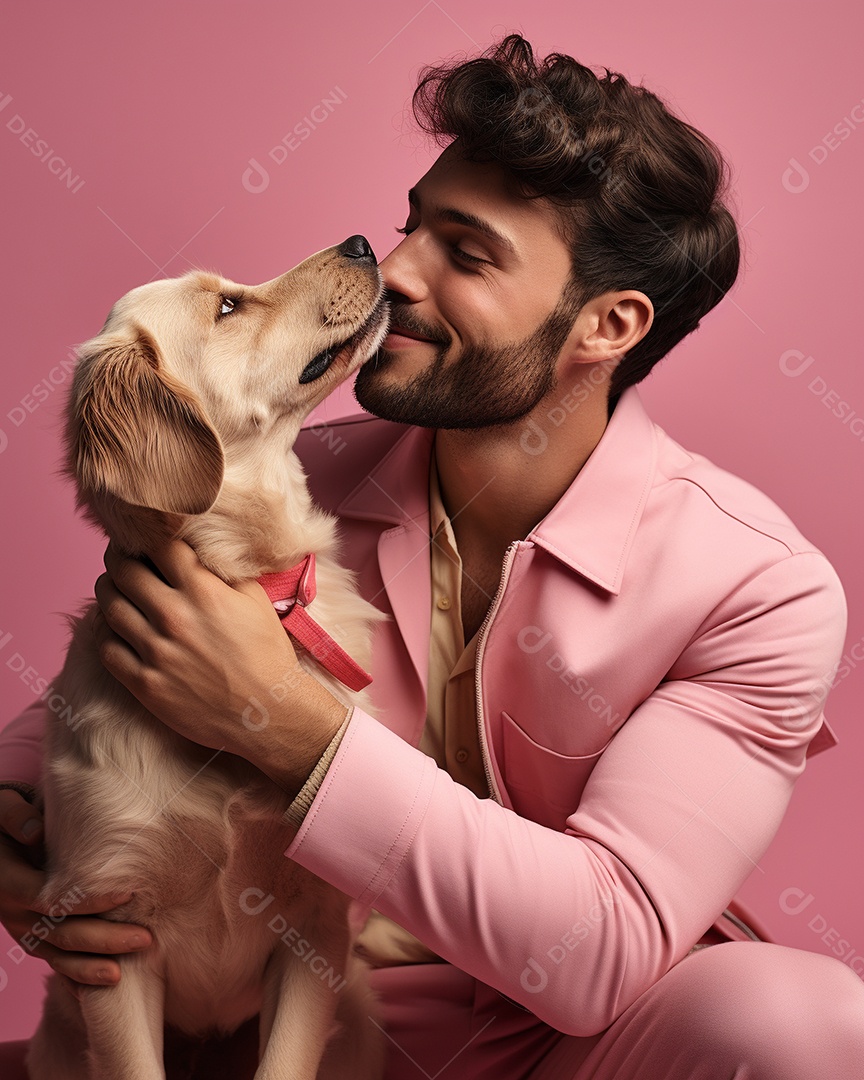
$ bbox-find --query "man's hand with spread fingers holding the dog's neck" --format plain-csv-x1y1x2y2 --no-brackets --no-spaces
94,540,346,797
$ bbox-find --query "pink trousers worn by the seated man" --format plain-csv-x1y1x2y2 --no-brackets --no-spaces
0,942,864,1080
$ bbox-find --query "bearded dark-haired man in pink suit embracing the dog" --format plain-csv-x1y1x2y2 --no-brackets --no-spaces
0,36,864,1080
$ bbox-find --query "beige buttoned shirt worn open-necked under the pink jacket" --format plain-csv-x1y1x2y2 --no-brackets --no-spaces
349,442,489,967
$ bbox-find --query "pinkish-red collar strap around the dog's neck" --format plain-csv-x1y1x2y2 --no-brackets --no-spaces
258,555,372,690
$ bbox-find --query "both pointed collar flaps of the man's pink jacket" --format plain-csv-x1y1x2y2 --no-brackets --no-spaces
336,387,657,595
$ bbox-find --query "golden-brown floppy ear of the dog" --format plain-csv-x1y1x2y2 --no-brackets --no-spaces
67,332,225,514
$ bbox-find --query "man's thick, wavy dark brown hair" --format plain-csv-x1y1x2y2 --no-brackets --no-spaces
413,33,740,400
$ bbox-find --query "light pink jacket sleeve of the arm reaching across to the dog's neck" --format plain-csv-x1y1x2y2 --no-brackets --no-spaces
285,552,846,1036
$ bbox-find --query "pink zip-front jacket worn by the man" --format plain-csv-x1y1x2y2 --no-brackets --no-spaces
0,389,846,1035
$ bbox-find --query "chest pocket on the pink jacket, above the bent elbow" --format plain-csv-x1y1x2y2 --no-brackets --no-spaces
501,712,610,829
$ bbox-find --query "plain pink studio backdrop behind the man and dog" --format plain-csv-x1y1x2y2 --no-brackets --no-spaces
0,0,864,1038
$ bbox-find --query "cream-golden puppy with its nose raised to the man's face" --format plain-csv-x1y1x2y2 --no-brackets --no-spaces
27,237,389,1080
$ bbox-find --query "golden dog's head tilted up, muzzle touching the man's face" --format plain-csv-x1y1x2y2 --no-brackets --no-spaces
66,237,388,523
